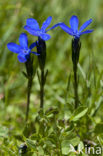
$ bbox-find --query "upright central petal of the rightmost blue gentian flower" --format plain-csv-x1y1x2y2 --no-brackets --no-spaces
70,16,79,33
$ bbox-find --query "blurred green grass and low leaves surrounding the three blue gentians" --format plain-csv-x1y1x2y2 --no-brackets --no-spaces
0,0,103,156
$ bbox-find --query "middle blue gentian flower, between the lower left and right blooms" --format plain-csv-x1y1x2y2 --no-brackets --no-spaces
24,16,60,41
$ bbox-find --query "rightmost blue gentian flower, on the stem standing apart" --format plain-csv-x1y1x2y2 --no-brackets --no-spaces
60,15,93,38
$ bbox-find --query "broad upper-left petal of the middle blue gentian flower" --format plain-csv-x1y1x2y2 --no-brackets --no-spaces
26,18,40,30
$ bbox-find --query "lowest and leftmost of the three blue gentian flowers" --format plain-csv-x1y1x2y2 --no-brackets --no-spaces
7,33,39,63
